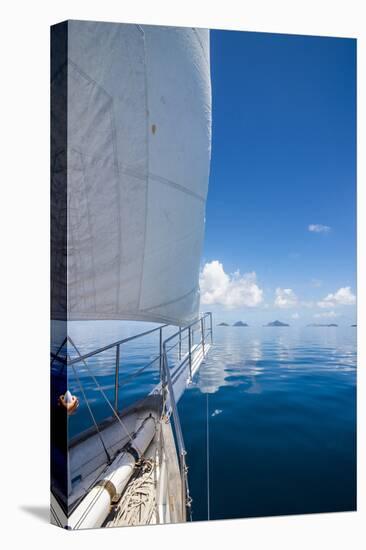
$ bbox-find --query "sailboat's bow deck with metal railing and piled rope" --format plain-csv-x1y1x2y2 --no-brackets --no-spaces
50,314,212,528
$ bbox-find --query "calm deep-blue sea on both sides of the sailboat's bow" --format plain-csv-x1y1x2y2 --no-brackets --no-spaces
55,322,356,520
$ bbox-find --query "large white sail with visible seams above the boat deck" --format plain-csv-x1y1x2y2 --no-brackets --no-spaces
52,21,211,325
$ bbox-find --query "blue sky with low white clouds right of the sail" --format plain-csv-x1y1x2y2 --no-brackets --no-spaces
201,31,356,323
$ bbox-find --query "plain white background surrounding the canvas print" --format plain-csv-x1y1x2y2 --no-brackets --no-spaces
0,0,366,550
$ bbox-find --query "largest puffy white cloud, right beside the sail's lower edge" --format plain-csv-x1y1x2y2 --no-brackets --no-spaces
200,260,263,309
